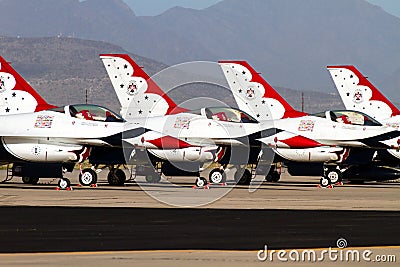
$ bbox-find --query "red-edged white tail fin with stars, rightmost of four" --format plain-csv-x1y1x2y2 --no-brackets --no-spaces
327,65,400,120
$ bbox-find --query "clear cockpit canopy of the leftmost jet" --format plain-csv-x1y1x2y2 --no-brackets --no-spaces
52,104,124,122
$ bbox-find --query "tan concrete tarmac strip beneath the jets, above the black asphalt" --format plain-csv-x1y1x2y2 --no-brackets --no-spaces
0,172,400,211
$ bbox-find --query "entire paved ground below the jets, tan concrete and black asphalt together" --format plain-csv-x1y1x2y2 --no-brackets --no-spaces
0,170,400,266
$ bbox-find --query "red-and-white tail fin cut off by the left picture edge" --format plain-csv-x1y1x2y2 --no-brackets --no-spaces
0,56,55,115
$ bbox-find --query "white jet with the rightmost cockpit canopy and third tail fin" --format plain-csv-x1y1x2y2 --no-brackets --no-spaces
219,61,398,185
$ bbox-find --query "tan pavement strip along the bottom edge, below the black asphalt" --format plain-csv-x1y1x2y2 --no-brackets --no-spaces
0,250,400,267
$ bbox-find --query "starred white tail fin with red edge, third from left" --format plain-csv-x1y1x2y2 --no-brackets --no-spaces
218,61,306,120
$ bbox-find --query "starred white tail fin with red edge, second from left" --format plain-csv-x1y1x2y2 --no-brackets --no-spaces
100,54,185,117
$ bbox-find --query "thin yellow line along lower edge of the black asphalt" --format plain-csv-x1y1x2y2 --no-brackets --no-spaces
0,245,400,257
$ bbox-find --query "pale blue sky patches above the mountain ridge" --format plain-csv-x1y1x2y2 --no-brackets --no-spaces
124,0,400,17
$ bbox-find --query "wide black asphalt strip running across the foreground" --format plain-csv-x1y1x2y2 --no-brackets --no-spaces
0,207,400,253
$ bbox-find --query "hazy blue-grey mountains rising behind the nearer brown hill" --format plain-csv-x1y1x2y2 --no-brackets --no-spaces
0,0,400,102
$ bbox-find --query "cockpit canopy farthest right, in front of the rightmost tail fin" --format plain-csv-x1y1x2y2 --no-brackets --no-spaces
313,110,382,126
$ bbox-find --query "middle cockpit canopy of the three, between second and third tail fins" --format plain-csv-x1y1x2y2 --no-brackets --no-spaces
191,107,258,123
